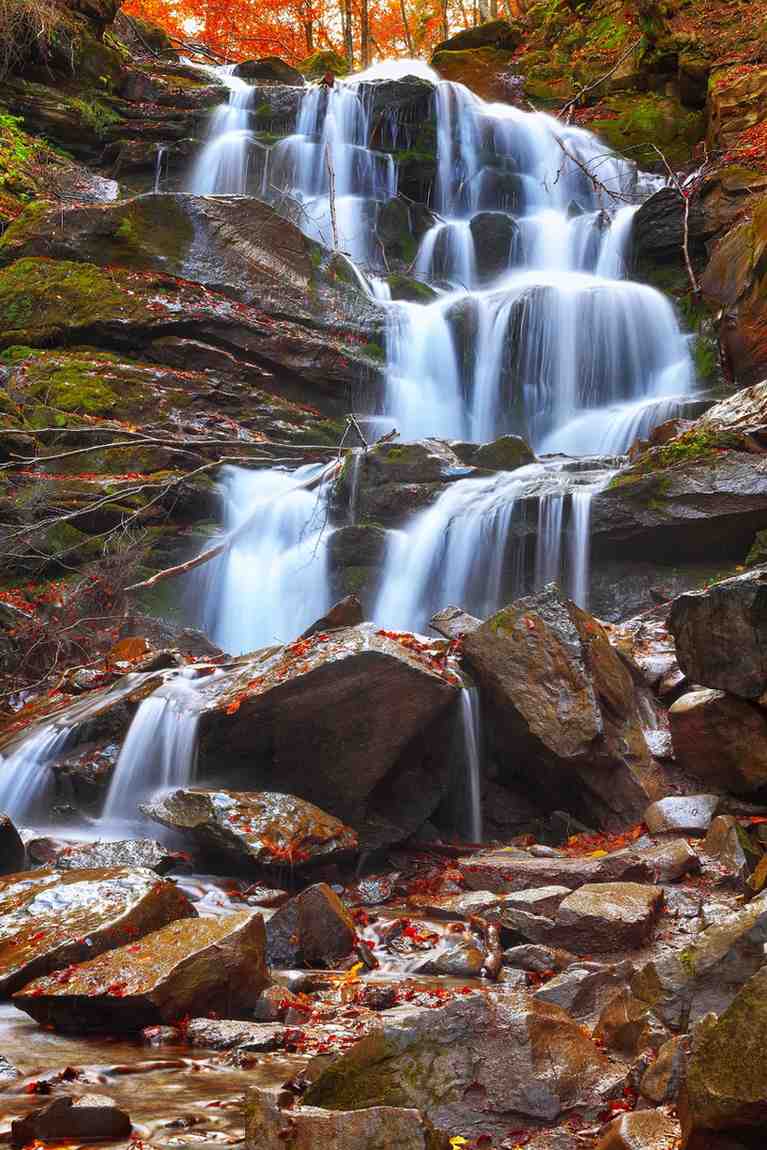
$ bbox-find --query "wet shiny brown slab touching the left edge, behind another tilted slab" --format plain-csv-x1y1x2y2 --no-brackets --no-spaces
0,867,195,995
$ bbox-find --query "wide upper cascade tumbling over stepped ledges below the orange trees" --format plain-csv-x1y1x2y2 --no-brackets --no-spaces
183,61,695,454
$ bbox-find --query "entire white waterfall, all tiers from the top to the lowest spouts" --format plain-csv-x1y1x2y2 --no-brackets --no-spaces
0,61,695,840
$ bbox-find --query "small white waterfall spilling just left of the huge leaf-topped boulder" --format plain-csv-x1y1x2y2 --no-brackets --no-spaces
102,672,201,822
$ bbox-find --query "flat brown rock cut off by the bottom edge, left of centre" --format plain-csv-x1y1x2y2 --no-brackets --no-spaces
245,1089,450,1150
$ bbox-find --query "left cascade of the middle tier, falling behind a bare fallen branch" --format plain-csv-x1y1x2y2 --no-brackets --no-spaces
194,463,330,654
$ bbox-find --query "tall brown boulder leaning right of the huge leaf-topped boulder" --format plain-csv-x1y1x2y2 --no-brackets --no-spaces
463,585,657,828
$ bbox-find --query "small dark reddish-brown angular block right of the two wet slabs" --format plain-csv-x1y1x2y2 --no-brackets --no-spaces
267,882,356,967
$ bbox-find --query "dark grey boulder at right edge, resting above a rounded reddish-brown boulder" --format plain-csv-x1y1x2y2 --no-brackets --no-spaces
668,568,767,699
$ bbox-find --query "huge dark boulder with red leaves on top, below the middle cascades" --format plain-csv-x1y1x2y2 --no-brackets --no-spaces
192,623,460,845
